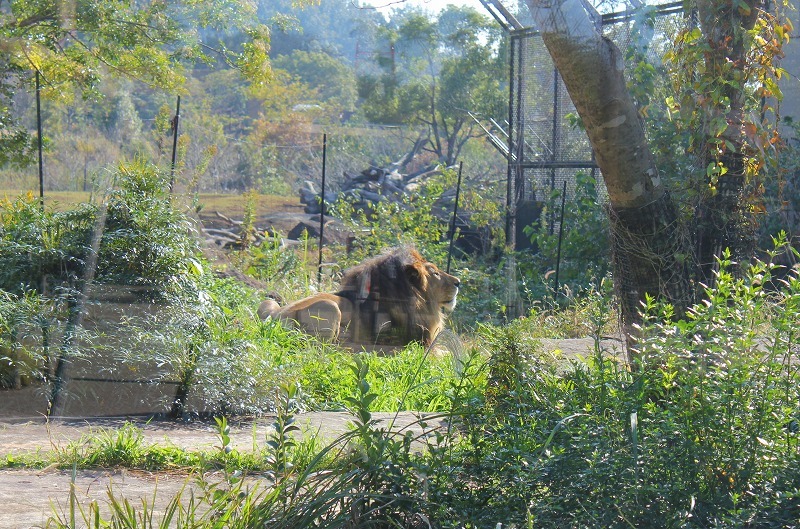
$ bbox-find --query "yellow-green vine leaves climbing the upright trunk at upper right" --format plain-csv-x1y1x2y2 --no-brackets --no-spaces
664,0,791,178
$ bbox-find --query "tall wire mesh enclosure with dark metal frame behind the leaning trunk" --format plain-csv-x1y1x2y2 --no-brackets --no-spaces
482,0,686,247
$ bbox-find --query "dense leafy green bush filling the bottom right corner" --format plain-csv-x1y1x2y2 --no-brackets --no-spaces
430,241,800,527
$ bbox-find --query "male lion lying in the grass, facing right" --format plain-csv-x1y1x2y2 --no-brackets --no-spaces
258,247,461,346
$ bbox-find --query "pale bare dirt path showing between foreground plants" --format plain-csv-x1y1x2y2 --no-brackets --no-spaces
0,339,622,529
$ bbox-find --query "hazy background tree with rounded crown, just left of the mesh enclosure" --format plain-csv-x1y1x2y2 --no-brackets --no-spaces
359,5,507,165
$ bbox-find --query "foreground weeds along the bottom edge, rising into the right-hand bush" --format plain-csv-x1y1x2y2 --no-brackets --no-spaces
40,242,800,528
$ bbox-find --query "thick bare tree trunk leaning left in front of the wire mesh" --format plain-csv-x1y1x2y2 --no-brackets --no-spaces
529,0,691,346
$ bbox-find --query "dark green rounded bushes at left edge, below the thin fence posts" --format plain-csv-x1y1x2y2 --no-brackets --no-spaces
0,160,198,292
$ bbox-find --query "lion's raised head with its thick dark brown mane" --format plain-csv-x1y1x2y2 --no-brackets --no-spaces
338,247,461,345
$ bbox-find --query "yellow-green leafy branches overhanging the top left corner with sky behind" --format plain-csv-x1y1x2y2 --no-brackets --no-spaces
0,0,270,166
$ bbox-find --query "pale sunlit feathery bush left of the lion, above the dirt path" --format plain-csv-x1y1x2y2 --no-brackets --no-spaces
115,274,288,416
